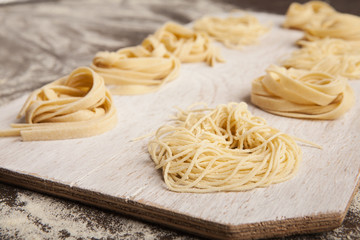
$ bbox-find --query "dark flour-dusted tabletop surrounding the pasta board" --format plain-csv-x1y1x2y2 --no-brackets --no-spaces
0,0,360,240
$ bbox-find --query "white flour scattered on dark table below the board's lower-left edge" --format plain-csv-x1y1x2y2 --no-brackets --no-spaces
0,191,196,240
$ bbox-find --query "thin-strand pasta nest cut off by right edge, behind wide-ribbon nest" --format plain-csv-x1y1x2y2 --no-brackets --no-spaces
282,38,360,79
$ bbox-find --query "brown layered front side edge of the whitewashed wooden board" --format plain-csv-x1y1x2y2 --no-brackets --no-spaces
0,168,352,240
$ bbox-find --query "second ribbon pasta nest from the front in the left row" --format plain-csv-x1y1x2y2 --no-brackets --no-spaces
91,39,180,95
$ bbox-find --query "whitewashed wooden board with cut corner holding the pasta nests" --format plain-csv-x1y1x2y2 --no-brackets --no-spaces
0,13,360,239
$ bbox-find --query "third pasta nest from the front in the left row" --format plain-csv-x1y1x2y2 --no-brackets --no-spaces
142,22,224,66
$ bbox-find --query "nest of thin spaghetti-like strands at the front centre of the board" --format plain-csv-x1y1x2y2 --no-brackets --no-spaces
148,102,302,192
